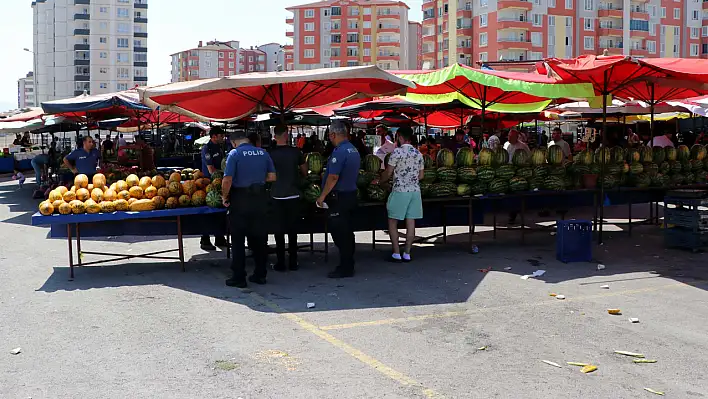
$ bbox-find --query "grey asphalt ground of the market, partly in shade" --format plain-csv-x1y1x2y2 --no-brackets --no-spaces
0,182,708,399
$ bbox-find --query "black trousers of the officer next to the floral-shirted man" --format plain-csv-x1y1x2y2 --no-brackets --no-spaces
326,191,357,272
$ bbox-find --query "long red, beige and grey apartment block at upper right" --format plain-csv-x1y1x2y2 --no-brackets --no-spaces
423,0,708,68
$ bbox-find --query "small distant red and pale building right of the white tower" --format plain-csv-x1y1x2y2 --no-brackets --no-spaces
172,40,240,82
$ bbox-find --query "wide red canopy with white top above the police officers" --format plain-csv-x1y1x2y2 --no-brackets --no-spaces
138,65,415,121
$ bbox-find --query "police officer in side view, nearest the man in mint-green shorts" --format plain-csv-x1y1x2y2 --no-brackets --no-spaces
317,121,361,278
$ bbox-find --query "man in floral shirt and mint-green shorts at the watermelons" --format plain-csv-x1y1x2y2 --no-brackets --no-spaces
381,126,425,262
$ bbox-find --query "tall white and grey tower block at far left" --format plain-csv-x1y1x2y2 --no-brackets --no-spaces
32,0,148,103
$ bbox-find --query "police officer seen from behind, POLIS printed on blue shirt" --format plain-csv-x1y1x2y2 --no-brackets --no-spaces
221,131,275,288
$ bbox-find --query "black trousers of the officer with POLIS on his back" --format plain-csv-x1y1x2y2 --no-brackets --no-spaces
229,186,268,278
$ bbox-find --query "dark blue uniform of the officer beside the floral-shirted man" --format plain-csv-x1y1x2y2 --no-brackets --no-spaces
323,140,361,275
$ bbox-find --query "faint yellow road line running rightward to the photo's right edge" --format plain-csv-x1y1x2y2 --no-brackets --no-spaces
319,280,706,331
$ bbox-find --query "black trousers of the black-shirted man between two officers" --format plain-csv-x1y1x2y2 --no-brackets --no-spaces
271,198,302,265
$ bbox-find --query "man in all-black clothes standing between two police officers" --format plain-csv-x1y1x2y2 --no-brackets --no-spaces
270,125,307,272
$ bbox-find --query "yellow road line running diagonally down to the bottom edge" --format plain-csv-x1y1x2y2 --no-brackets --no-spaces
243,291,444,399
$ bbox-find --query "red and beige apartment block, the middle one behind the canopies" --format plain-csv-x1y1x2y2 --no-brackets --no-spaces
285,0,415,70
